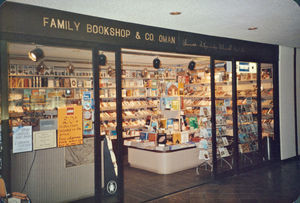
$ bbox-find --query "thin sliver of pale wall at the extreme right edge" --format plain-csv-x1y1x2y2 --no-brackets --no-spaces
296,48,300,155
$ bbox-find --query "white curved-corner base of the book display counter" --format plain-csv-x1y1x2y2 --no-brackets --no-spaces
128,146,203,174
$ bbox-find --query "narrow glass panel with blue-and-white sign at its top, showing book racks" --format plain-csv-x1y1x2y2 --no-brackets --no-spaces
236,62,260,168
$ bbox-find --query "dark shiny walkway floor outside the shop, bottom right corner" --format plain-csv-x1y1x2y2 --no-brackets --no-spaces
151,160,300,203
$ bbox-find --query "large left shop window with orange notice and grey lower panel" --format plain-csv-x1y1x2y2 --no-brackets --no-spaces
8,43,94,202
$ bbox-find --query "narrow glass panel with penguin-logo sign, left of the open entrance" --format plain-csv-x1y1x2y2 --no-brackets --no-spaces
93,49,123,202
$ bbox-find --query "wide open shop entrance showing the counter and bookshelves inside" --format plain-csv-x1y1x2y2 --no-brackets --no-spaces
122,49,213,202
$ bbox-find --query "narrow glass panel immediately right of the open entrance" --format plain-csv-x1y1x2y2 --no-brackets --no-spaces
214,61,234,173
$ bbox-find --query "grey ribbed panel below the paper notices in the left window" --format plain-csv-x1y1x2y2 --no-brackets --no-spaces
11,148,94,203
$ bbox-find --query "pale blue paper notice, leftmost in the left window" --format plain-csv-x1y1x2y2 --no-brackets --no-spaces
13,126,32,153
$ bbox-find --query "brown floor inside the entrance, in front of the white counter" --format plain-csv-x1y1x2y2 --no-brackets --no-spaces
124,166,212,203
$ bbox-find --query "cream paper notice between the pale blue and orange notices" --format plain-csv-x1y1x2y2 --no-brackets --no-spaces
33,130,56,150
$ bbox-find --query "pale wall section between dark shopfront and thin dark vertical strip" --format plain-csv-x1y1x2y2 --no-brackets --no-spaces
279,46,296,160
